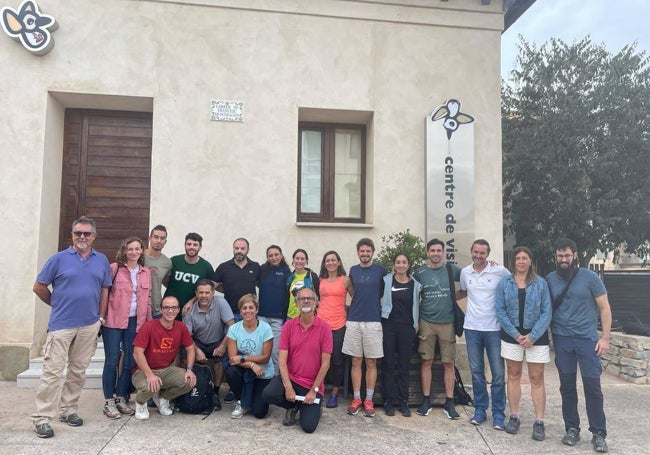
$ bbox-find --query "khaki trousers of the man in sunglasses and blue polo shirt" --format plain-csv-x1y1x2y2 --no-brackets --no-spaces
32,321,101,424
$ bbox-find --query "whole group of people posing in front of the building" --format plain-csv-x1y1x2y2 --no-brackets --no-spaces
33,217,611,452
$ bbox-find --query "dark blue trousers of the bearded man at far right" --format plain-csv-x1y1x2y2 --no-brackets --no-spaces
553,335,607,436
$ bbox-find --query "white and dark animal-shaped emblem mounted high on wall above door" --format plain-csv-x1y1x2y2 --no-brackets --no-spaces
2,0,59,55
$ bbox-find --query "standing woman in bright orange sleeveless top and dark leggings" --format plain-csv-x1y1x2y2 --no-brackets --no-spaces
318,251,353,408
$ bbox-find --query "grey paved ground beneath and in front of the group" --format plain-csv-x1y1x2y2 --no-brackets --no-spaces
0,364,650,455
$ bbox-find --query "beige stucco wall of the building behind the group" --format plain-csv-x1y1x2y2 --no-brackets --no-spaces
0,0,503,366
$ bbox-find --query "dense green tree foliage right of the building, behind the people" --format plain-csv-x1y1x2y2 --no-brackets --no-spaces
502,37,650,268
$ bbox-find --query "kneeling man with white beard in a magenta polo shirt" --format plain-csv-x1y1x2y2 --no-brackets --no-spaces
262,288,332,433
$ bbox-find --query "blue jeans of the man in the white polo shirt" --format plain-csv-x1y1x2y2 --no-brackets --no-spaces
465,329,506,417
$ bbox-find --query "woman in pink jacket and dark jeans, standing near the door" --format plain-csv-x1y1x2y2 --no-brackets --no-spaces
100,237,151,419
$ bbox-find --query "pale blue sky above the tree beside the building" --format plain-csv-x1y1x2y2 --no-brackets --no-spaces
501,0,650,80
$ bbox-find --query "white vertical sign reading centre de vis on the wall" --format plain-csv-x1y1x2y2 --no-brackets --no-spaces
425,99,475,266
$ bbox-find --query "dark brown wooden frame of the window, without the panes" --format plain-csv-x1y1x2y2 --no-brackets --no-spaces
296,122,367,223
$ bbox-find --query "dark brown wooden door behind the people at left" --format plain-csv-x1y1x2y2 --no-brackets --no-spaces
59,109,151,262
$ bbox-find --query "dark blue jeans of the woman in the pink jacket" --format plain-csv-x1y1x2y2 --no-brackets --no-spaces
102,316,137,400
